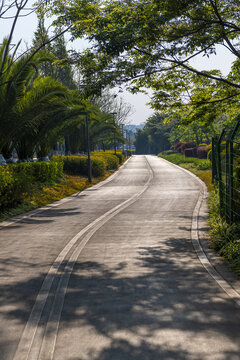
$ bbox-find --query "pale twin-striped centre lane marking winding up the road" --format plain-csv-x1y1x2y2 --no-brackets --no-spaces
13,158,153,360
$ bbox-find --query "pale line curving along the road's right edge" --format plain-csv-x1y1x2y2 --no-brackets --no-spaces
159,158,240,306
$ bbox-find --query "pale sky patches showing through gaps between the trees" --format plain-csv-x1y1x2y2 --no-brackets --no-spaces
0,2,234,124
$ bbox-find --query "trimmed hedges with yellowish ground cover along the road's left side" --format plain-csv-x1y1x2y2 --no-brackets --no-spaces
0,152,125,221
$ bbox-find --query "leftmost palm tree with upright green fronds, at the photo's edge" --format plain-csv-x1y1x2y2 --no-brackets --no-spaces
0,39,54,156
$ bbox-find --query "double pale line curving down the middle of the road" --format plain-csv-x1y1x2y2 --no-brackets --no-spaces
13,158,153,360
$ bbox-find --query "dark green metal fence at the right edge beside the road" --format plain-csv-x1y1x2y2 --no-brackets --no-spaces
212,118,240,223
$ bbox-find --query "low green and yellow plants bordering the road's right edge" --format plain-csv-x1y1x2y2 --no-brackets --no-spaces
158,151,240,276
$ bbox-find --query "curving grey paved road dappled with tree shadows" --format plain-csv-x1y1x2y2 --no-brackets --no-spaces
0,156,240,360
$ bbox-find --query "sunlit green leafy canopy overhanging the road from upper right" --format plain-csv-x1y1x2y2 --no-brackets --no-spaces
42,0,240,122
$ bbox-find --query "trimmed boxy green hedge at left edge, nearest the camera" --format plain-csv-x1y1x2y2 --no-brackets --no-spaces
0,161,63,210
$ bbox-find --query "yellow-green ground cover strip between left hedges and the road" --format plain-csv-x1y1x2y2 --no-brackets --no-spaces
0,171,112,221
